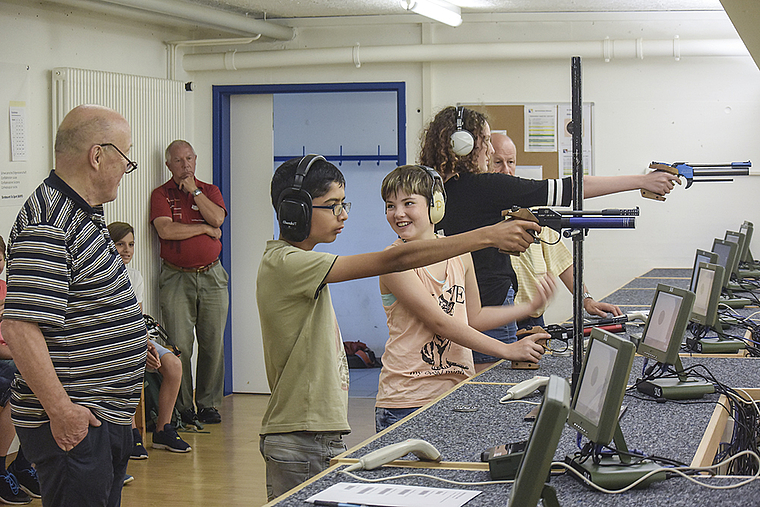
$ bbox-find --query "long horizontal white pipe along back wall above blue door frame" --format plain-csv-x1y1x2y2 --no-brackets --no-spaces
182,37,749,72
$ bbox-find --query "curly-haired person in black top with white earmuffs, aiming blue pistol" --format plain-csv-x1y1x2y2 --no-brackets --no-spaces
420,106,678,370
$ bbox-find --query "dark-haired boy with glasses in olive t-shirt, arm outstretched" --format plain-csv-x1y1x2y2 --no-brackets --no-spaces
256,155,539,500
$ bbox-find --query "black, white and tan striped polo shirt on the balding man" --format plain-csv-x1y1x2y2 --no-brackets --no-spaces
3,171,147,428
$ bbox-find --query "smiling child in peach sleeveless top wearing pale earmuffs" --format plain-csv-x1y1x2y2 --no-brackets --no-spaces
375,165,554,431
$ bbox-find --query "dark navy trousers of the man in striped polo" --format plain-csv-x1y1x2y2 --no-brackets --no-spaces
16,421,134,507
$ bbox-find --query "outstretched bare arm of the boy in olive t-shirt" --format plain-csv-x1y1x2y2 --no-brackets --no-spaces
325,220,540,283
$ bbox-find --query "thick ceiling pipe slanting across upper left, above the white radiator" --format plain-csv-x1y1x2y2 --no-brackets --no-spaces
45,0,295,40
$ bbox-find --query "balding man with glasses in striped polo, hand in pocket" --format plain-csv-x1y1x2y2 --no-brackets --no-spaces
2,105,147,507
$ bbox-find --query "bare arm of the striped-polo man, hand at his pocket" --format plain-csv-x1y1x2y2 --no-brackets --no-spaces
2,320,100,451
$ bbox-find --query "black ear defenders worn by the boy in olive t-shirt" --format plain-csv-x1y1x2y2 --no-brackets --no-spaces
277,154,325,243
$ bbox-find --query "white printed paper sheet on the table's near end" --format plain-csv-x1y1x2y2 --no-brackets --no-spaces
306,482,481,507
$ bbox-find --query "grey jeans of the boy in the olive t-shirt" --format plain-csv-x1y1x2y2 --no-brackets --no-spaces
259,431,346,501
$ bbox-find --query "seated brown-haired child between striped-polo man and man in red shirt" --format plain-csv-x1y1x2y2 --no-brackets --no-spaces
108,222,192,459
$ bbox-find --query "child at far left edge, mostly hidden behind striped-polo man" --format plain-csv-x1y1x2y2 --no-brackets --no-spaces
0,237,41,505
